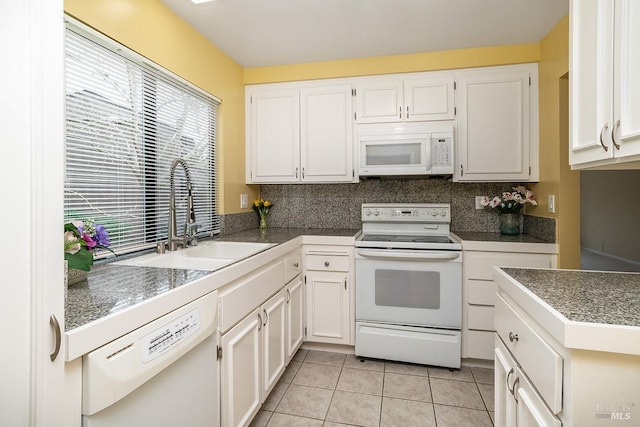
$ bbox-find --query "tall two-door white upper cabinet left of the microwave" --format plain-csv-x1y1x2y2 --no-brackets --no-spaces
246,84,356,184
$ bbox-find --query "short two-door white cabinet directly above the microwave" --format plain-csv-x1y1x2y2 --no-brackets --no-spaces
356,74,455,123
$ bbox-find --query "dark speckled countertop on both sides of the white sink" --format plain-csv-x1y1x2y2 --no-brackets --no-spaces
65,228,358,331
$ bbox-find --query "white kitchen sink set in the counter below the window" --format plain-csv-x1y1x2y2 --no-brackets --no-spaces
115,240,274,271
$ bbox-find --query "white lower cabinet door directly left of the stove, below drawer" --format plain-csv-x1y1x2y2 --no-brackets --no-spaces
307,271,350,344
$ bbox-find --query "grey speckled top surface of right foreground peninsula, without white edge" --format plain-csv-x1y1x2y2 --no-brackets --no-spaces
503,268,640,327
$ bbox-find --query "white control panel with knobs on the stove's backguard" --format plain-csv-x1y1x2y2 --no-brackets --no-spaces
361,203,451,223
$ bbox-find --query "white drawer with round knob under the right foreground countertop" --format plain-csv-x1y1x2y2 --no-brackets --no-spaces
495,295,562,414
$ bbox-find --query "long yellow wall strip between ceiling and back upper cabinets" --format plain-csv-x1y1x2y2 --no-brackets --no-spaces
244,44,540,85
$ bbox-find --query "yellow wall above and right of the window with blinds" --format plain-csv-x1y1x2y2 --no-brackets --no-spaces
64,0,257,214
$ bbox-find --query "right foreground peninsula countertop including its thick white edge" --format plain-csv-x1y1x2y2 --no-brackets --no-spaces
496,268,640,355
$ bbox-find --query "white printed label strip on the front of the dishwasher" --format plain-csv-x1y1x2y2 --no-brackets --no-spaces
138,308,200,363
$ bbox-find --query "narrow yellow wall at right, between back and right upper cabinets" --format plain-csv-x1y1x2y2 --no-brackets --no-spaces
527,16,580,268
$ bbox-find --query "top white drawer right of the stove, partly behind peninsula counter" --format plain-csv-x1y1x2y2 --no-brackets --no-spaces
464,252,552,280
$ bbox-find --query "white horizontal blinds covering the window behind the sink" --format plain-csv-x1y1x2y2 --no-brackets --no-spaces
65,23,220,255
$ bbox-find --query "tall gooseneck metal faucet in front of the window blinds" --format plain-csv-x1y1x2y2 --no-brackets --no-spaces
168,159,198,251
